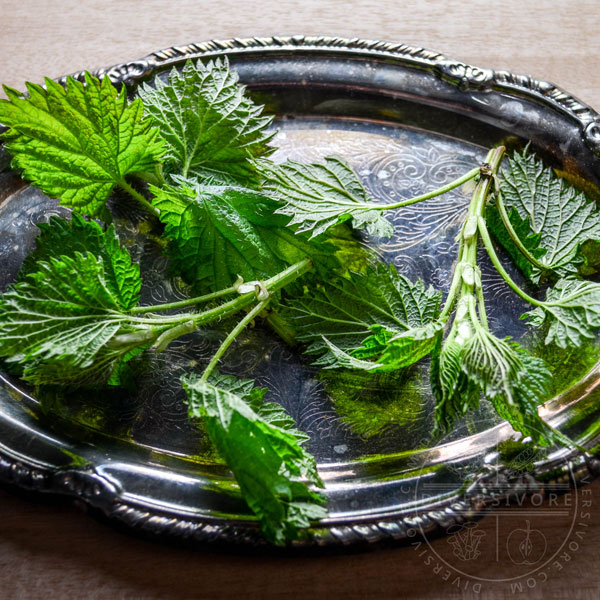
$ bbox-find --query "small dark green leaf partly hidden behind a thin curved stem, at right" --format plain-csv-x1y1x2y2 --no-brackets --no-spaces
485,205,547,283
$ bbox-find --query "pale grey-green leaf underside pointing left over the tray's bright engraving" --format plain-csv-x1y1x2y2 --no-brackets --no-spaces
259,156,394,237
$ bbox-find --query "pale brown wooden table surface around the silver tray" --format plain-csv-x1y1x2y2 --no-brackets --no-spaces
0,0,600,599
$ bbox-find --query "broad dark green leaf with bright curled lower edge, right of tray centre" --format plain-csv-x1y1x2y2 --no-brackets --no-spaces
288,263,441,370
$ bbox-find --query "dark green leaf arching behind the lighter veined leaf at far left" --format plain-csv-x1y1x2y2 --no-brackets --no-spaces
19,213,141,310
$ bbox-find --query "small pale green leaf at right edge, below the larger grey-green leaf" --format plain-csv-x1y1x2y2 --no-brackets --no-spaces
523,279,600,348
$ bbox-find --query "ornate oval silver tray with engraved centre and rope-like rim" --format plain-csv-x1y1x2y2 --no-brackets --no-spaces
0,36,600,548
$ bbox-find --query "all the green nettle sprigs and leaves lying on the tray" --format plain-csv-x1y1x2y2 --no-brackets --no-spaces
0,60,600,544
